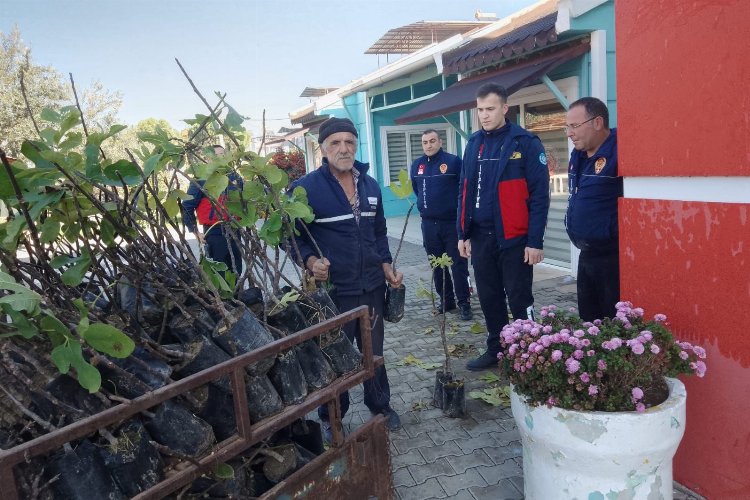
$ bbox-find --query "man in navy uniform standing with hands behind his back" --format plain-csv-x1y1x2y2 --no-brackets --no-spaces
409,129,472,321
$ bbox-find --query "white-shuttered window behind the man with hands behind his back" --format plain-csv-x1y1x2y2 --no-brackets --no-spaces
381,124,456,185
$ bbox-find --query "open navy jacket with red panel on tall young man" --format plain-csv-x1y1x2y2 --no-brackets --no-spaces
456,123,550,249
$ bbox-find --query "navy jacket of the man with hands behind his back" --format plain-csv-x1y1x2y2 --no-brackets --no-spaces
409,148,461,221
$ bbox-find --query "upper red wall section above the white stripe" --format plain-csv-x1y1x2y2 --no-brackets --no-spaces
615,0,750,176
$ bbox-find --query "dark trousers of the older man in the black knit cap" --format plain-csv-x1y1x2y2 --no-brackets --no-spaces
318,284,391,420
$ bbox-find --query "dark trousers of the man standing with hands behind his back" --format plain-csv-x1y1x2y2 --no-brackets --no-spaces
422,219,469,309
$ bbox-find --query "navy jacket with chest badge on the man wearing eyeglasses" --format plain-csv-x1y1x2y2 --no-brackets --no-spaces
565,128,623,253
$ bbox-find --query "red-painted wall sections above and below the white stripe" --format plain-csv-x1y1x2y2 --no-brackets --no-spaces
615,0,750,500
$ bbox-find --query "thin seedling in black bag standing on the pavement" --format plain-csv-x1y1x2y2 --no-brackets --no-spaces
429,253,466,418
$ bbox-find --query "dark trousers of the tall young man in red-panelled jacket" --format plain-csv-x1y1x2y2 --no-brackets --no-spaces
470,229,534,354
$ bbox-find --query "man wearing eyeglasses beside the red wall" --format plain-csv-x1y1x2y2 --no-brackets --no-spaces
565,97,623,321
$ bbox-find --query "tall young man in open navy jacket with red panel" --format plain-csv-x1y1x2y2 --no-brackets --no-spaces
457,83,549,370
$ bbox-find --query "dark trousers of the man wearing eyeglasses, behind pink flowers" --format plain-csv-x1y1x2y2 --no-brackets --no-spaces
576,250,620,321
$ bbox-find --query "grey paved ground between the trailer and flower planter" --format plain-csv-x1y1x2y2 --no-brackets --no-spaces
334,235,696,500
